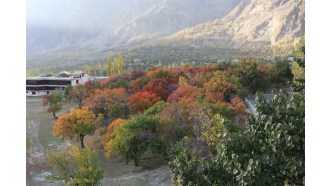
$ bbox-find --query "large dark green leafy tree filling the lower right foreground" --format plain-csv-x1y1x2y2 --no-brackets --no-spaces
170,91,305,185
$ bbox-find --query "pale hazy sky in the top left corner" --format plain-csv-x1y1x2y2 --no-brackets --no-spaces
26,0,125,27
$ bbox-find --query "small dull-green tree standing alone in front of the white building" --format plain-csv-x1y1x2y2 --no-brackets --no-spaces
42,90,63,118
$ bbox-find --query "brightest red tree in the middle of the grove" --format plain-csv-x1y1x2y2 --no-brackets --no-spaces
129,91,161,112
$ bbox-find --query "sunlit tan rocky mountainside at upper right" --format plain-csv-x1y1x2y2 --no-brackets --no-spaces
162,0,305,50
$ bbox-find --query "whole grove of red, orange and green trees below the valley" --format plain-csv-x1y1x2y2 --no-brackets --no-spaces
44,37,305,185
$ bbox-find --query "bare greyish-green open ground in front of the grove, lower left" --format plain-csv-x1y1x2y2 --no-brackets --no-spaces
26,97,171,186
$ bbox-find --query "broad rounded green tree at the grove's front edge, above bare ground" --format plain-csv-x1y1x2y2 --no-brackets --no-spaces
105,114,175,166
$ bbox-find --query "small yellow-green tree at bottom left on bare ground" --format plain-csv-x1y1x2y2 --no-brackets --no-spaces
46,146,103,186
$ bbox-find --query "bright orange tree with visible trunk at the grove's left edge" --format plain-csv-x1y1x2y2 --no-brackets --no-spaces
53,107,103,148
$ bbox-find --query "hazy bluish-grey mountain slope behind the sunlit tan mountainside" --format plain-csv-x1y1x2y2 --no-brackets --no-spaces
98,0,240,45
